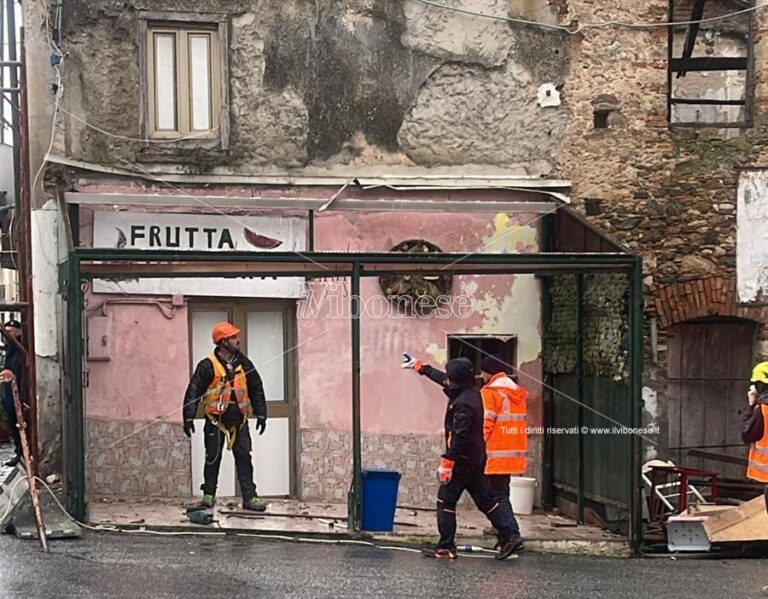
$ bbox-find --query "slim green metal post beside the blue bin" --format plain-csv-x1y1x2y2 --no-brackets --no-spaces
347,262,362,530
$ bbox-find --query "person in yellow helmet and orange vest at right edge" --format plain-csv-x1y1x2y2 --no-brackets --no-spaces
741,362,768,510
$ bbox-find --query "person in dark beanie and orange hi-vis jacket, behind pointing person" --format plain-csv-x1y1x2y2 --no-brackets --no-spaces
480,356,528,532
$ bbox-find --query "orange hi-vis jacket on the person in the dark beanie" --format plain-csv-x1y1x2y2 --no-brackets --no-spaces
481,372,528,474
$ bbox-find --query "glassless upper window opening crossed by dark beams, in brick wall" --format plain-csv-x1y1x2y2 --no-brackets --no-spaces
667,0,754,127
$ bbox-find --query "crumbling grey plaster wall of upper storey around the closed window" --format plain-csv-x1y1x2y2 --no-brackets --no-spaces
33,0,569,175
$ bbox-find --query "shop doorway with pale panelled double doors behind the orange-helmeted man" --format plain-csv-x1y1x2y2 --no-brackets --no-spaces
189,300,297,497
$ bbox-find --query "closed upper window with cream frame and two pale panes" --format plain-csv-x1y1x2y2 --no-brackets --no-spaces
141,13,229,148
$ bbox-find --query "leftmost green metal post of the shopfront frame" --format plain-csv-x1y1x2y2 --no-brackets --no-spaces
62,252,86,521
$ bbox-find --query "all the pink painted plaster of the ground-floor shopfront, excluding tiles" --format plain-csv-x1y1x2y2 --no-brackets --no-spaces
75,188,541,435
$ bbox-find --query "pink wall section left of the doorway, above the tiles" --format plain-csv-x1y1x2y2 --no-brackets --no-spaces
85,294,189,422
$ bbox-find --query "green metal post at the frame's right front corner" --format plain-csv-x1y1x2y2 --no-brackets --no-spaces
629,257,644,553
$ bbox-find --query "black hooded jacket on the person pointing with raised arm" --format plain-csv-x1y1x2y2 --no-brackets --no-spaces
419,358,485,467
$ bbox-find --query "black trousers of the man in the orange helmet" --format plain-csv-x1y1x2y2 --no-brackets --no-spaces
201,418,256,501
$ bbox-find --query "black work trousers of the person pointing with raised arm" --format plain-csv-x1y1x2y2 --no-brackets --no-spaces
437,464,519,549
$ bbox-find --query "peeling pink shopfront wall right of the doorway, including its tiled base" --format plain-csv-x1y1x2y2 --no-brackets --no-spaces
298,212,542,505
